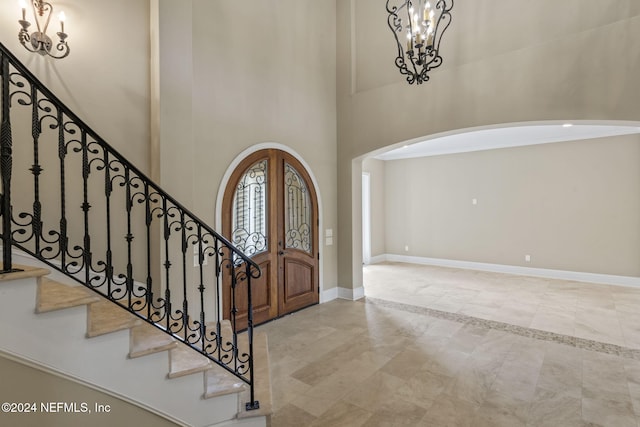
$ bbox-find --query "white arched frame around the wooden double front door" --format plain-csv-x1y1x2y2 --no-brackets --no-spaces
215,142,324,313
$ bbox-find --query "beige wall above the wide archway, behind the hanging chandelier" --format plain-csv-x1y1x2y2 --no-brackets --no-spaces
337,0,640,287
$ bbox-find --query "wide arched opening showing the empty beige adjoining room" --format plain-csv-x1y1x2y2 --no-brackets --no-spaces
353,121,640,294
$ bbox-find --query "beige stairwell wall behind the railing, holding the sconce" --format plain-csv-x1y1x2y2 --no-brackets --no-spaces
0,0,150,280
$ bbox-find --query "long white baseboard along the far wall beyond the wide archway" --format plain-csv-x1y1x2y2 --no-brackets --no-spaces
371,254,640,288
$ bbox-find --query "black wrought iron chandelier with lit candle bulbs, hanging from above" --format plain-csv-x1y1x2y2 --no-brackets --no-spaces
387,0,453,84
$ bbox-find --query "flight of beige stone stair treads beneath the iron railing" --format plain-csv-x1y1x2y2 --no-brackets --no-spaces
0,258,272,425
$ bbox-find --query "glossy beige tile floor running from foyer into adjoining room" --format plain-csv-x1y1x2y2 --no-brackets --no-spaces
258,263,640,427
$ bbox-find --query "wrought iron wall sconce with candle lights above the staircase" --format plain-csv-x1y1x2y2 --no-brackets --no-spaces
18,0,69,59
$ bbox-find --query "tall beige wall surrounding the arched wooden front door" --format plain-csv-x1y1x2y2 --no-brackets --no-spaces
160,0,337,298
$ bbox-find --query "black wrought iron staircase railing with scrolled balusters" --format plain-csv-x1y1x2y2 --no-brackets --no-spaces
0,44,260,410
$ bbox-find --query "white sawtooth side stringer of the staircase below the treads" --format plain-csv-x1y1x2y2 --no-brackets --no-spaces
0,278,264,426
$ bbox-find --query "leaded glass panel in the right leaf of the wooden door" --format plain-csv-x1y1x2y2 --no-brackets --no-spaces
284,163,313,253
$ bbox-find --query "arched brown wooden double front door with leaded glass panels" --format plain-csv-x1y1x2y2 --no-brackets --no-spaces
222,149,319,329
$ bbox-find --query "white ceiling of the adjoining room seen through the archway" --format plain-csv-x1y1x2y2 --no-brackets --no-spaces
374,122,640,160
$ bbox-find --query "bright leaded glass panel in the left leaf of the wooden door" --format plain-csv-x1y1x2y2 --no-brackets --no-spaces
231,160,267,256
